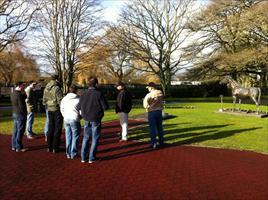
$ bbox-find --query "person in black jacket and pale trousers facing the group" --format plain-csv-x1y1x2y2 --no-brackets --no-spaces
115,81,132,141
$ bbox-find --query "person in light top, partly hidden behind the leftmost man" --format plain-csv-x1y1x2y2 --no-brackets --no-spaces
25,81,36,139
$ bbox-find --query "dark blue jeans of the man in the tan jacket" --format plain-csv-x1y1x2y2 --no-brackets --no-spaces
148,110,164,145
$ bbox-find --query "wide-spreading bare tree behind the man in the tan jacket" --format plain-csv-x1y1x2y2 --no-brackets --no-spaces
115,0,192,95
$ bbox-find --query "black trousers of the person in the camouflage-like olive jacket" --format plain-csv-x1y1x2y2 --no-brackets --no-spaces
47,110,63,152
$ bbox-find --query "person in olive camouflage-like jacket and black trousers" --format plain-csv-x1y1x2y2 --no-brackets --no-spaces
43,75,63,153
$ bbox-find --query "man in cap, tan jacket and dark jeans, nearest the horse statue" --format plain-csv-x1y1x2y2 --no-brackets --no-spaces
143,82,164,149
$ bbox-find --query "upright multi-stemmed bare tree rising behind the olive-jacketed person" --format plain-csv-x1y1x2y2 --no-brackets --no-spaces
31,0,100,92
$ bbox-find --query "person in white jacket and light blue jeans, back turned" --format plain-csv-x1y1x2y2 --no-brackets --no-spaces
60,85,81,159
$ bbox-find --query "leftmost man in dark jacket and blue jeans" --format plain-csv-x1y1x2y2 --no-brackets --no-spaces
11,82,27,152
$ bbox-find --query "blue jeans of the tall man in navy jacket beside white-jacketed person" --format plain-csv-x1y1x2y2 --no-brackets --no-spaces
81,121,101,161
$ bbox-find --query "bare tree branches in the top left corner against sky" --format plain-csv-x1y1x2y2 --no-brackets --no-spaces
0,0,37,51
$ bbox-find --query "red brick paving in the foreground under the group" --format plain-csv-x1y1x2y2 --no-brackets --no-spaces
0,119,268,200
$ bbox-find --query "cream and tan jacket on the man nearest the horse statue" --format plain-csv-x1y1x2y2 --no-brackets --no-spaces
143,89,164,112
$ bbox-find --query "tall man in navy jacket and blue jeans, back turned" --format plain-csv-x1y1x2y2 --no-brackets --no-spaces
78,77,108,163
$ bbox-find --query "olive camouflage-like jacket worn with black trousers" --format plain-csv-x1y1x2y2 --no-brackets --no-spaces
43,80,63,111
